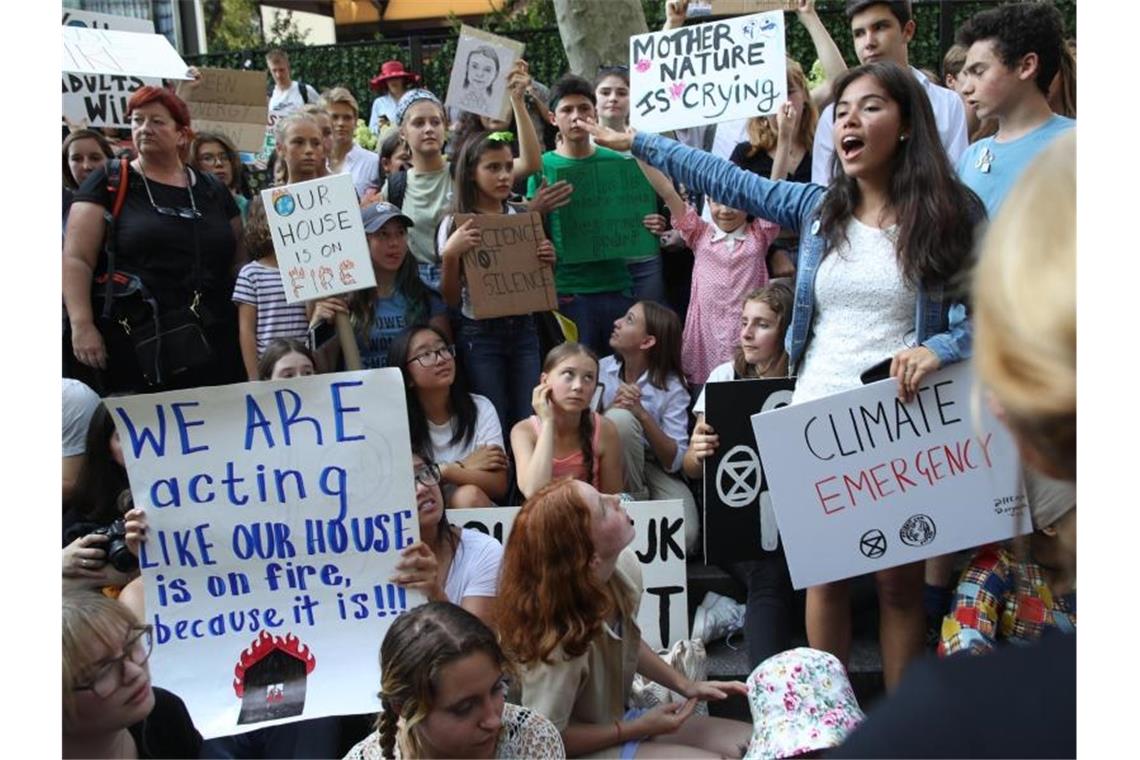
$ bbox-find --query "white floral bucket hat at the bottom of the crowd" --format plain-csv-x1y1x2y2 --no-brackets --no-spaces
744,646,863,760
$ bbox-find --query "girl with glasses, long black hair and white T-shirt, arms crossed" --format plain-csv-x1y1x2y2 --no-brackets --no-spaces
388,326,510,507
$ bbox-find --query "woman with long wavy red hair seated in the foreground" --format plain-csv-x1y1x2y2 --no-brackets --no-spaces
496,479,751,758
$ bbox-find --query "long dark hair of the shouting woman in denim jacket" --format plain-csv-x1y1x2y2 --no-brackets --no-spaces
820,62,985,287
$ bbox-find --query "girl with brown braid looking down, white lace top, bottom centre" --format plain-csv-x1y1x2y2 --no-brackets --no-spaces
345,602,565,760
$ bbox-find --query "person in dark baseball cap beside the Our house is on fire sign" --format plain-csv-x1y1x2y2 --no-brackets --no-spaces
310,202,451,369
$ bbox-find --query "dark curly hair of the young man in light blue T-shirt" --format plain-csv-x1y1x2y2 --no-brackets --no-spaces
958,2,1065,95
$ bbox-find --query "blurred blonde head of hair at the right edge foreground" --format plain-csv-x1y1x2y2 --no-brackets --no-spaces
974,130,1076,479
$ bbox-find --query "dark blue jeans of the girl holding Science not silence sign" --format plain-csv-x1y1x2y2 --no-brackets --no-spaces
454,314,542,432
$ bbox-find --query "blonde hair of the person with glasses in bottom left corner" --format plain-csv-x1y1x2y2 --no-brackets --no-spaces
63,590,139,727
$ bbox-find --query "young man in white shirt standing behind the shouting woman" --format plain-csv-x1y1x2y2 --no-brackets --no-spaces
812,0,969,185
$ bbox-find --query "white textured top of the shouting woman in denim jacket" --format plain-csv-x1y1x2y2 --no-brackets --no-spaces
792,216,918,403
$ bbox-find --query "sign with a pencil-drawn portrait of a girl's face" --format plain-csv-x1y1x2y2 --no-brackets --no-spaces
443,25,526,121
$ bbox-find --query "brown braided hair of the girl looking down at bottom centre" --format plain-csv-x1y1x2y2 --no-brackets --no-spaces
376,602,508,758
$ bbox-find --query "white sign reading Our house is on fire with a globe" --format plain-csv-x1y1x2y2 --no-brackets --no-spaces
261,174,376,303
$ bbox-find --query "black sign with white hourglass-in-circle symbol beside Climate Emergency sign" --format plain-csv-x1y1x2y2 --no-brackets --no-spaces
705,377,796,563
